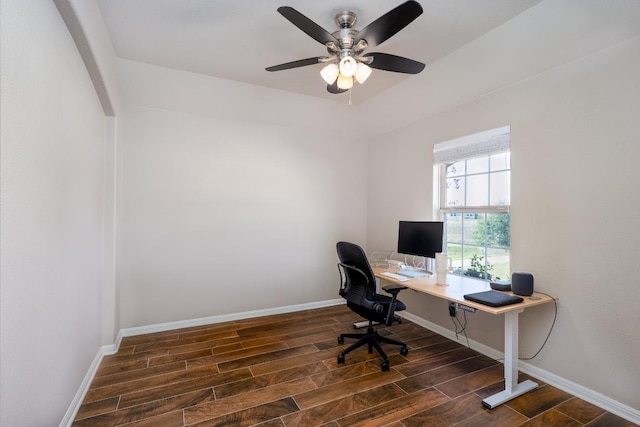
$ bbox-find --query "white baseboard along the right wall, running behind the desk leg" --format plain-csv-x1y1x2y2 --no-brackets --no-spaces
398,311,640,425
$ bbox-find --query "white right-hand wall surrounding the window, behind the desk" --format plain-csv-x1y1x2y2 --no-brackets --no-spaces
368,37,640,409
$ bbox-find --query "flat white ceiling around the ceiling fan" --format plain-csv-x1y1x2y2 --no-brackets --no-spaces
98,0,540,102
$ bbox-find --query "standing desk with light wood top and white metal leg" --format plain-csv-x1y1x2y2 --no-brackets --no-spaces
372,267,553,409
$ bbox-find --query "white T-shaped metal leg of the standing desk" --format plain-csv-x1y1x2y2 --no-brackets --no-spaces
482,310,538,409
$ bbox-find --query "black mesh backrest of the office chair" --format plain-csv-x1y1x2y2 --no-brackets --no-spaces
336,242,381,311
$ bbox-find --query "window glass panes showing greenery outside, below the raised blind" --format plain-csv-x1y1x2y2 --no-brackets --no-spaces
441,152,511,280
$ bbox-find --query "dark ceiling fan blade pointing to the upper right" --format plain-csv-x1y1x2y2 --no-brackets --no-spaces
357,0,422,47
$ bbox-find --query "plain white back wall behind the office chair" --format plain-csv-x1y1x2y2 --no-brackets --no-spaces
112,61,367,328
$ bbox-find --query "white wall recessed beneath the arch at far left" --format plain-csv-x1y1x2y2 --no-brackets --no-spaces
0,0,105,426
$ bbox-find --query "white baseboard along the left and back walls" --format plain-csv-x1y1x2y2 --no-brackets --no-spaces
60,298,346,427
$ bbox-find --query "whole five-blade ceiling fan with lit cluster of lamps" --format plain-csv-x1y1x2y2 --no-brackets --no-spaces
266,0,424,93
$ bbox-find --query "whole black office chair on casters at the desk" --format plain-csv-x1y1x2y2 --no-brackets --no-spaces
336,242,409,371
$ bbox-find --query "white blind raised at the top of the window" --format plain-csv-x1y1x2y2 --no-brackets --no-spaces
433,126,511,164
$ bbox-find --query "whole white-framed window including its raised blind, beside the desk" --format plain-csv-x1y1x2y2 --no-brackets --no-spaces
434,127,511,280
